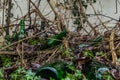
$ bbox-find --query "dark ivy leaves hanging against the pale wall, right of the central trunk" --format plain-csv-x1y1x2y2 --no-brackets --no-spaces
72,0,96,31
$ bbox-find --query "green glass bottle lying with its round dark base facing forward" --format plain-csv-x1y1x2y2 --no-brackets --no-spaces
35,61,72,80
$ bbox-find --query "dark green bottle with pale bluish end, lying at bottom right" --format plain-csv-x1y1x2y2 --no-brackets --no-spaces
84,60,115,80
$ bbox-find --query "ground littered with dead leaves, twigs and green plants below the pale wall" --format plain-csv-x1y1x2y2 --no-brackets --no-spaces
0,31,120,80
